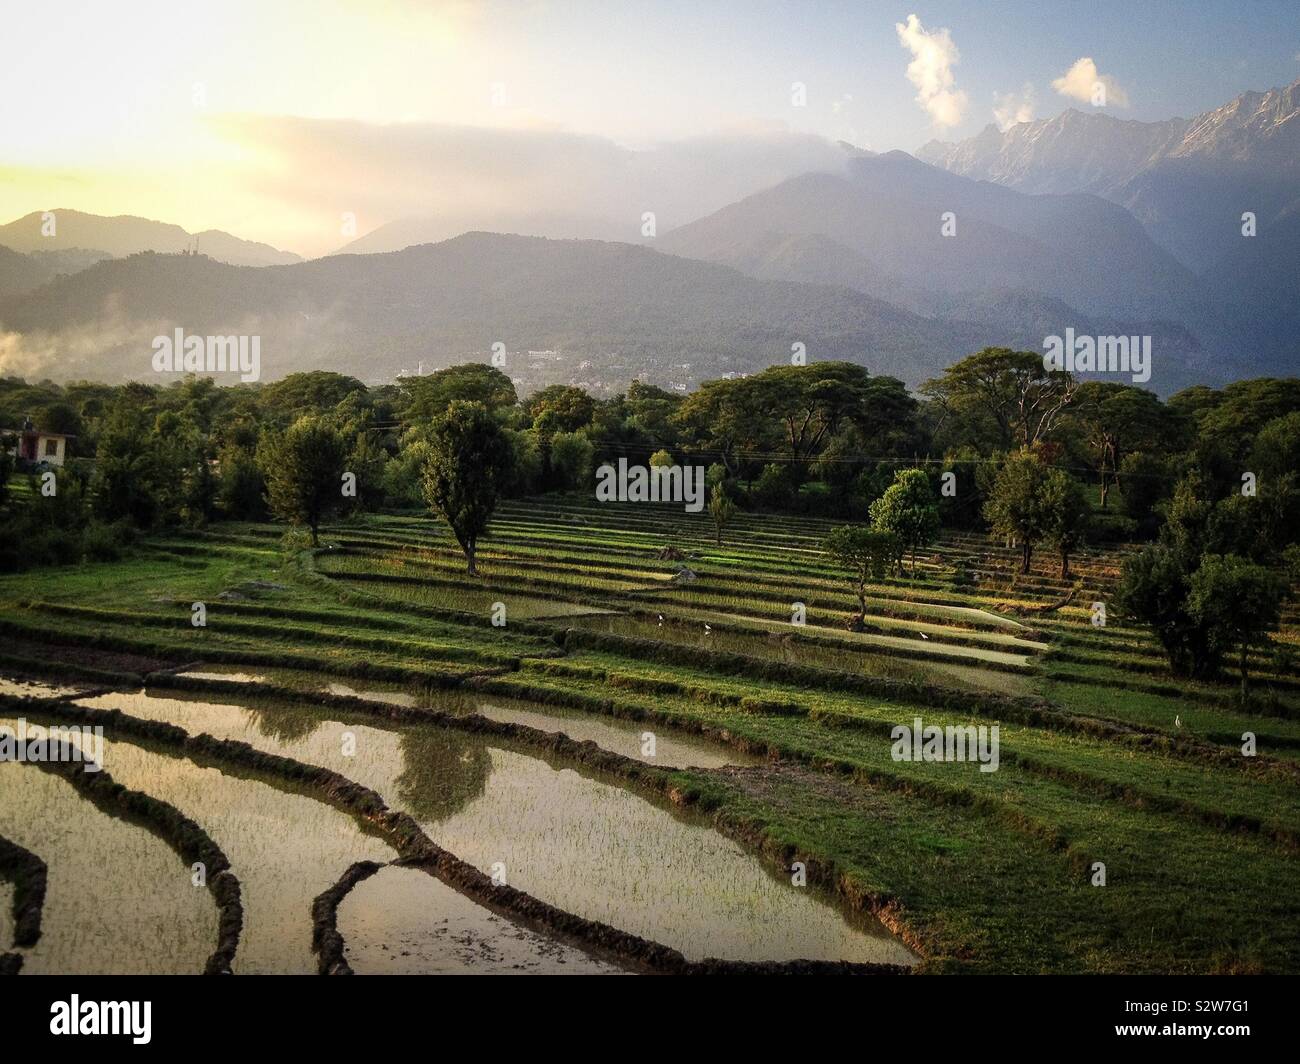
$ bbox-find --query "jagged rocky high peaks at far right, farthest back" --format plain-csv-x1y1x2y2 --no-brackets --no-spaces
920,81,1300,369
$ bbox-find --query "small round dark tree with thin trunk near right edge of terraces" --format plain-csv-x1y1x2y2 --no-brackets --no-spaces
1187,554,1287,701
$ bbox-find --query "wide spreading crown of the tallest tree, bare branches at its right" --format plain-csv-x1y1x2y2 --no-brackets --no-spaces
920,347,1078,450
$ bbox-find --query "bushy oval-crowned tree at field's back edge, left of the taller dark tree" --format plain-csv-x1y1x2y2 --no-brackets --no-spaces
257,415,348,546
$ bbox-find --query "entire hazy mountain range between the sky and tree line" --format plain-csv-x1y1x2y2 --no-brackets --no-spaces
0,83,1300,394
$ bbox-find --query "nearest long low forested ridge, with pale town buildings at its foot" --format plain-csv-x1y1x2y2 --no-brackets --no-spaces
0,233,997,386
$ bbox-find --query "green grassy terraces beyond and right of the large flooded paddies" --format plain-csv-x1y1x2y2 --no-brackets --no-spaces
0,497,1300,972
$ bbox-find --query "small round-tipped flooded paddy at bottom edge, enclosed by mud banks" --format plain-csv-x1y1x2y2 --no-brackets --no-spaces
338,865,621,976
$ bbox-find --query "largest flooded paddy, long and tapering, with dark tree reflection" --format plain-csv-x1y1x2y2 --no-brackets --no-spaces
76,695,911,964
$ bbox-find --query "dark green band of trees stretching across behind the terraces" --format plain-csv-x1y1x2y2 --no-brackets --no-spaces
0,347,1300,691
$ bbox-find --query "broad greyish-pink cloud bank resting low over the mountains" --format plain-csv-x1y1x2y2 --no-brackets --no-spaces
216,116,849,254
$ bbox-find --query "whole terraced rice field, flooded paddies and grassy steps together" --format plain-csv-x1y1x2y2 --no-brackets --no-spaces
0,496,1300,976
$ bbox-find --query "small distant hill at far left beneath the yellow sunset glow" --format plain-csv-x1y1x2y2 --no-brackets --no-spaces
0,209,302,265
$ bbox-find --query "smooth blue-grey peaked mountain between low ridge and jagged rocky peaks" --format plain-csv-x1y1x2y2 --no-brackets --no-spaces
657,152,1200,321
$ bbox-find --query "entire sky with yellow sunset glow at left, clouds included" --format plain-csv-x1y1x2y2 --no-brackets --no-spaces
0,0,1300,255
